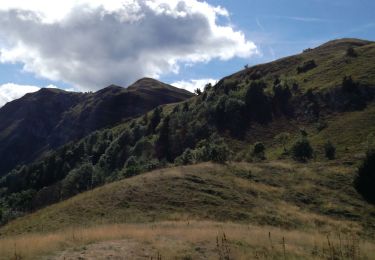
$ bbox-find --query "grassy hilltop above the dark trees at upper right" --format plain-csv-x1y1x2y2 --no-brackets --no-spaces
229,39,375,91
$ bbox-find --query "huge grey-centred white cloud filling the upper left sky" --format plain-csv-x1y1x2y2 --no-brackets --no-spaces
0,0,257,90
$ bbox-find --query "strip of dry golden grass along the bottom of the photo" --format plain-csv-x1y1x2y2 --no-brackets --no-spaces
0,221,375,259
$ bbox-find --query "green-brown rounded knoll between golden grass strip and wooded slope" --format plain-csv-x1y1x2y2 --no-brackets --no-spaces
0,161,374,237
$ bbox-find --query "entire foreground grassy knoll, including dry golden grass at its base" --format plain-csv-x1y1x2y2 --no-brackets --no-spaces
0,160,375,259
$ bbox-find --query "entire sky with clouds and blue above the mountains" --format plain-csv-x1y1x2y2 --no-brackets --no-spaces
0,0,375,106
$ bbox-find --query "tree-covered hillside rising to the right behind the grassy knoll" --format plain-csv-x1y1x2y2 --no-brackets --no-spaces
0,39,375,233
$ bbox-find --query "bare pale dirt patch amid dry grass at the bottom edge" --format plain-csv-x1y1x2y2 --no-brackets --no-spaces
46,240,158,260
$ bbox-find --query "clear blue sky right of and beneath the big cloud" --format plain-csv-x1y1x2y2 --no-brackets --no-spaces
166,0,375,81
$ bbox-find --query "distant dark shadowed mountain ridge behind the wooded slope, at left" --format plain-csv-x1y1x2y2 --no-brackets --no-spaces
0,78,193,176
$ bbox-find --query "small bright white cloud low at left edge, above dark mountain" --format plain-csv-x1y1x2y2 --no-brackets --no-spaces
0,83,41,107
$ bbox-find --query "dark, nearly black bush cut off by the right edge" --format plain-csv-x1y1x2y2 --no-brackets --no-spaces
355,150,375,203
